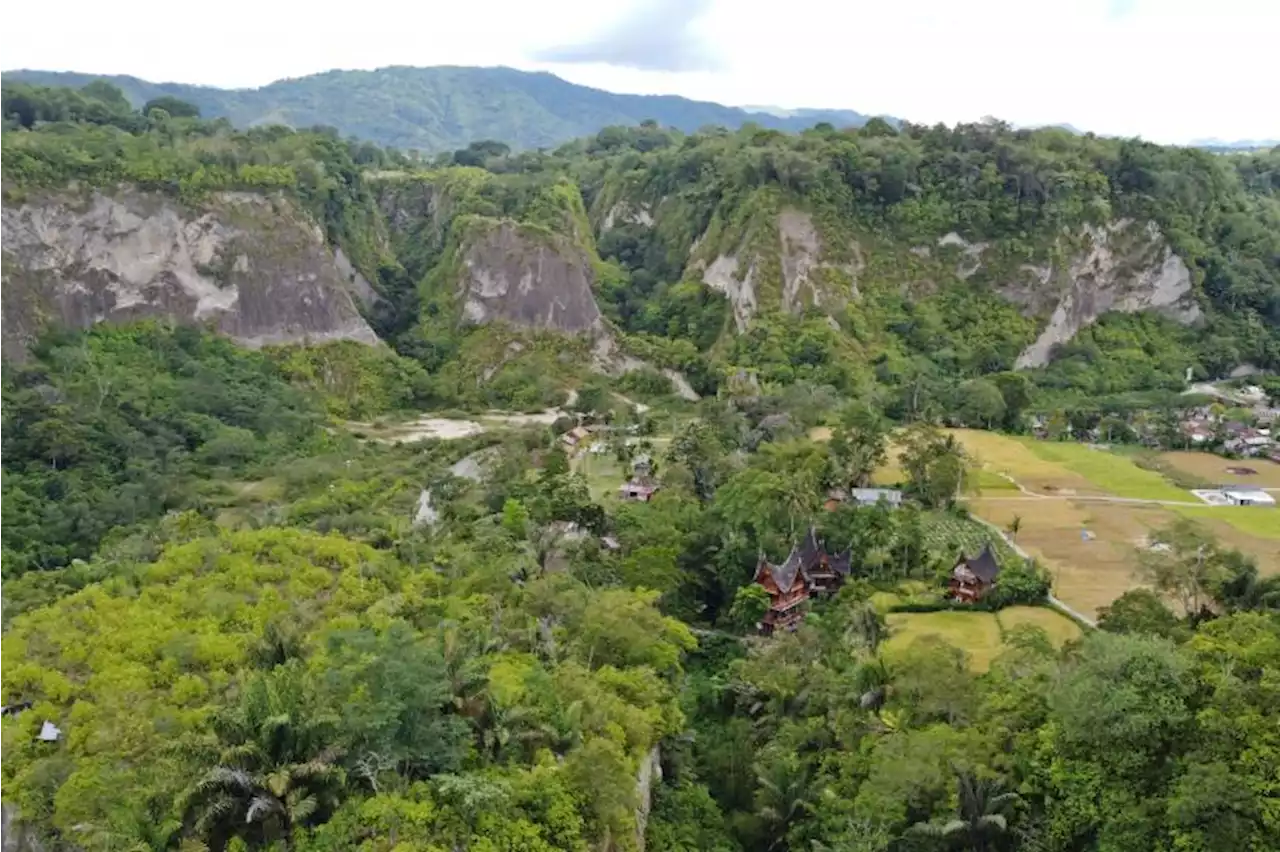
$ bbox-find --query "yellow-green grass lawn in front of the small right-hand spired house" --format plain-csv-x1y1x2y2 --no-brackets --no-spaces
884,606,1080,672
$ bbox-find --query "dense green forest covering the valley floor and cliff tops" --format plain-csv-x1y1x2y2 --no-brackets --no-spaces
0,76,1280,852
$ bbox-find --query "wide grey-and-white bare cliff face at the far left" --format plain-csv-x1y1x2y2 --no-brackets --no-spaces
0,191,378,358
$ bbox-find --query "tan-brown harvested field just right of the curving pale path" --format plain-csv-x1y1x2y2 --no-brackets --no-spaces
969,499,1174,615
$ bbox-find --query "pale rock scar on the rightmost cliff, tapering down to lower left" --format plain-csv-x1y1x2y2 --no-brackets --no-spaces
1001,219,1201,368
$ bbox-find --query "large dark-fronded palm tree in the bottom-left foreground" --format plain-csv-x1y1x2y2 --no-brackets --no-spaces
183,667,346,852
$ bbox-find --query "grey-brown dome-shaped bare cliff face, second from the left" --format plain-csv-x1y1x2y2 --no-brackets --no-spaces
460,223,603,334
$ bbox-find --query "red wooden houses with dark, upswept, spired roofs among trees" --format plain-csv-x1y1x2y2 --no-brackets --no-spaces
751,527,1000,636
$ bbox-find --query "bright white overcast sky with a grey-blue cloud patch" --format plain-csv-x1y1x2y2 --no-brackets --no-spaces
0,0,1280,142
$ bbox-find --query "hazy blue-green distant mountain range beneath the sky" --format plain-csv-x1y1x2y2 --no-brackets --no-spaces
0,67,890,152
